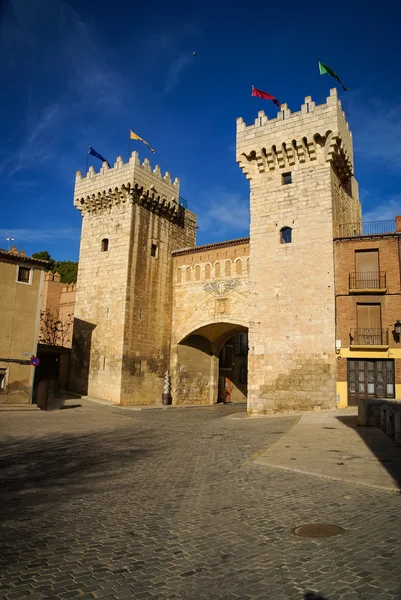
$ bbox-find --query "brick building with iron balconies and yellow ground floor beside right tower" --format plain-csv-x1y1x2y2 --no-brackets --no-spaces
334,223,401,407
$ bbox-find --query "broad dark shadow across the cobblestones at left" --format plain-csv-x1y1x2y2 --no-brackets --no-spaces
0,429,153,519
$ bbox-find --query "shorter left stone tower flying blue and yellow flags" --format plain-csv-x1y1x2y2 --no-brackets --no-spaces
70,152,196,404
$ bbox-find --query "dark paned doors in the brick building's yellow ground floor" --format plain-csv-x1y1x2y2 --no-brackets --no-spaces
347,359,395,406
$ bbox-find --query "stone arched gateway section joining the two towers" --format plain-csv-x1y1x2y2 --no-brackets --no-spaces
170,238,249,404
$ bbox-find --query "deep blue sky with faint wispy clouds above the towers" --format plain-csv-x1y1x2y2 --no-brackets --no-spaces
0,0,401,260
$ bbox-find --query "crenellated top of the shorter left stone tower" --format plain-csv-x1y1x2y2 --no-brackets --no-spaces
74,152,182,220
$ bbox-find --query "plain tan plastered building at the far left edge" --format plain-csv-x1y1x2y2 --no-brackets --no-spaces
0,246,48,404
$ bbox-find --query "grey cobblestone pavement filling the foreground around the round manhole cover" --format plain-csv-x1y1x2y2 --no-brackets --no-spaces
0,402,401,600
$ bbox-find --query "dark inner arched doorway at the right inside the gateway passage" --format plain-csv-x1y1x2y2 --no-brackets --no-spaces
217,333,248,403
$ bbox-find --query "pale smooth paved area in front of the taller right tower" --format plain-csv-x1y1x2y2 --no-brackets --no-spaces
255,408,401,491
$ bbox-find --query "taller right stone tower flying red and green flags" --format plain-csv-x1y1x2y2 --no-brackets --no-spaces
237,89,361,414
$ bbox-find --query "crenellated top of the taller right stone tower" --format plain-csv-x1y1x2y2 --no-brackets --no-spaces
237,88,354,181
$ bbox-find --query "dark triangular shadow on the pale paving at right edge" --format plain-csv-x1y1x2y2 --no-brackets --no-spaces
336,415,401,487
